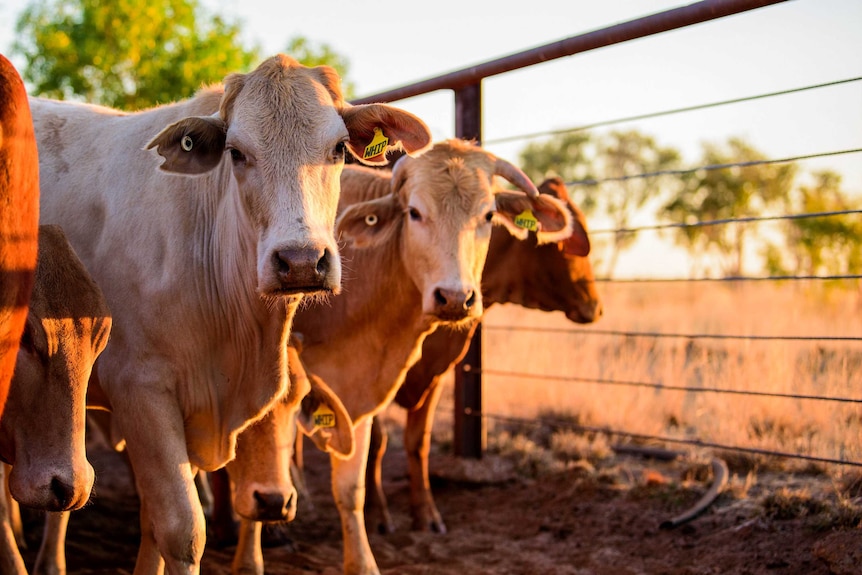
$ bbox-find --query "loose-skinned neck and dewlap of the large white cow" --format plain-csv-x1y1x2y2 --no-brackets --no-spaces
182,162,296,469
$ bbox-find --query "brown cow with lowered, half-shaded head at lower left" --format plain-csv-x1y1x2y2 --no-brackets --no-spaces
0,225,112,575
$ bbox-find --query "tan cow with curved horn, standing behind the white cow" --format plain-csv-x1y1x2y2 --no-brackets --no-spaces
276,140,572,574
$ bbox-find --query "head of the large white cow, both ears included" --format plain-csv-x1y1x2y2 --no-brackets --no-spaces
147,55,430,302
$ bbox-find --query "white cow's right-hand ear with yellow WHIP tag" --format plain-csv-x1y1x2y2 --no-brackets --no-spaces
341,104,431,166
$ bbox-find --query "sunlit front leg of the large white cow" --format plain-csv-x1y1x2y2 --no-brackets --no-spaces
114,396,206,575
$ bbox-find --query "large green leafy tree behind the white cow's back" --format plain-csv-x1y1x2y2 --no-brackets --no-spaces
13,0,258,110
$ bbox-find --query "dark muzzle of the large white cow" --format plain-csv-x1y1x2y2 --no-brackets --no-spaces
272,248,341,295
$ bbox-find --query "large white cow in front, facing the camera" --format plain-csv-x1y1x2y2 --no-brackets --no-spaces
30,51,431,575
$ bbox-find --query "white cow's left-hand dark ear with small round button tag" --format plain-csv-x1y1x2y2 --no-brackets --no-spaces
147,116,227,175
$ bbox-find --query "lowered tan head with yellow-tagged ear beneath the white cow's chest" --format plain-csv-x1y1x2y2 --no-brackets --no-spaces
227,334,353,521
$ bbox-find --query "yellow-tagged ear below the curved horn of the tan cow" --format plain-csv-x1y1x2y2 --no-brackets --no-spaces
494,191,573,244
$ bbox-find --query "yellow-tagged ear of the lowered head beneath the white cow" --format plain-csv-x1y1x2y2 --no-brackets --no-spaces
296,375,354,459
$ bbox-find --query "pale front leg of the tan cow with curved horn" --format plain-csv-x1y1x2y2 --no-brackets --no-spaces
329,417,380,575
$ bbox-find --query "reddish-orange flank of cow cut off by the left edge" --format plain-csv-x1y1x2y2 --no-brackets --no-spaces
0,54,39,424
